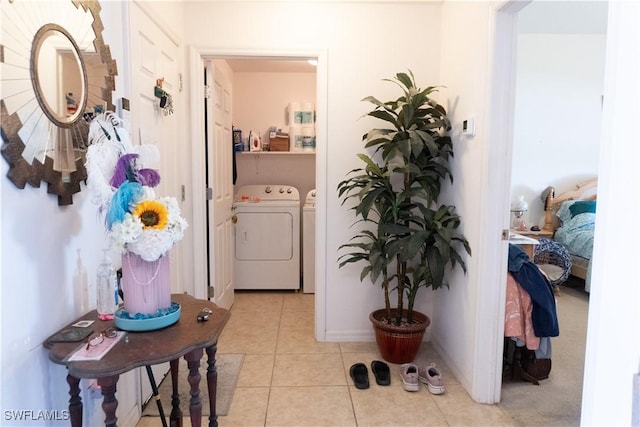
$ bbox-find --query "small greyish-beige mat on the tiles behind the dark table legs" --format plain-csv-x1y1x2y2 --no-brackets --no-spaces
142,354,244,419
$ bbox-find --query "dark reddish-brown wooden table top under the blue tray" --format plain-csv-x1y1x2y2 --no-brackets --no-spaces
43,294,230,378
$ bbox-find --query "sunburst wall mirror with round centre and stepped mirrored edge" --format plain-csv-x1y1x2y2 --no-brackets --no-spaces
0,0,117,205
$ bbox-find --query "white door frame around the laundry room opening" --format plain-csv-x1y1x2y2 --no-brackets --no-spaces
185,48,327,340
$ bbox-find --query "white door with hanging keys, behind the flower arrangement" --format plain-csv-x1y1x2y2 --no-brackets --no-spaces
129,2,183,410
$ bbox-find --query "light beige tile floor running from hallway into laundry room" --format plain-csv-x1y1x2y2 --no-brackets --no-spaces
138,292,514,427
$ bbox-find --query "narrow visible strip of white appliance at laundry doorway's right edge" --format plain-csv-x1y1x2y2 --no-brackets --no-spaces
302,190,316,294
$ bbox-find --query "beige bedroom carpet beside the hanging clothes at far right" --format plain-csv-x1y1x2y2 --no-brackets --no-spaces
499,277,589,426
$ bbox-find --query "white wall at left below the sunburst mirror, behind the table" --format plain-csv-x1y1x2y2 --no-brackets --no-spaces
0,2,182,426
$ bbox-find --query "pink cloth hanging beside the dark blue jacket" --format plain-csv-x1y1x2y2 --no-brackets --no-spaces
504,273,540,350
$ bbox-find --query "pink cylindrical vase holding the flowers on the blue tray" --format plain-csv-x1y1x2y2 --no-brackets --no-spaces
122,252,171,316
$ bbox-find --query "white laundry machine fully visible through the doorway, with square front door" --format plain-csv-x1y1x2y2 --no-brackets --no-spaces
234,185,300,290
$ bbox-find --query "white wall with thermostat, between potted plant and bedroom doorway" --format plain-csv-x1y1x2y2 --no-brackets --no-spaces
431,1,510,403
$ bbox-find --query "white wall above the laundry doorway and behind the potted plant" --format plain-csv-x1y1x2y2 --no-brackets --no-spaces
185,1,448,340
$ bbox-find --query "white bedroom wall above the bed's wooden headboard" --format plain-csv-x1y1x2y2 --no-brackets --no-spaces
511,33,606,226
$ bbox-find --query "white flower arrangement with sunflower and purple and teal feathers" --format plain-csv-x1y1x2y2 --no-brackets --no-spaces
86,112,188,262
